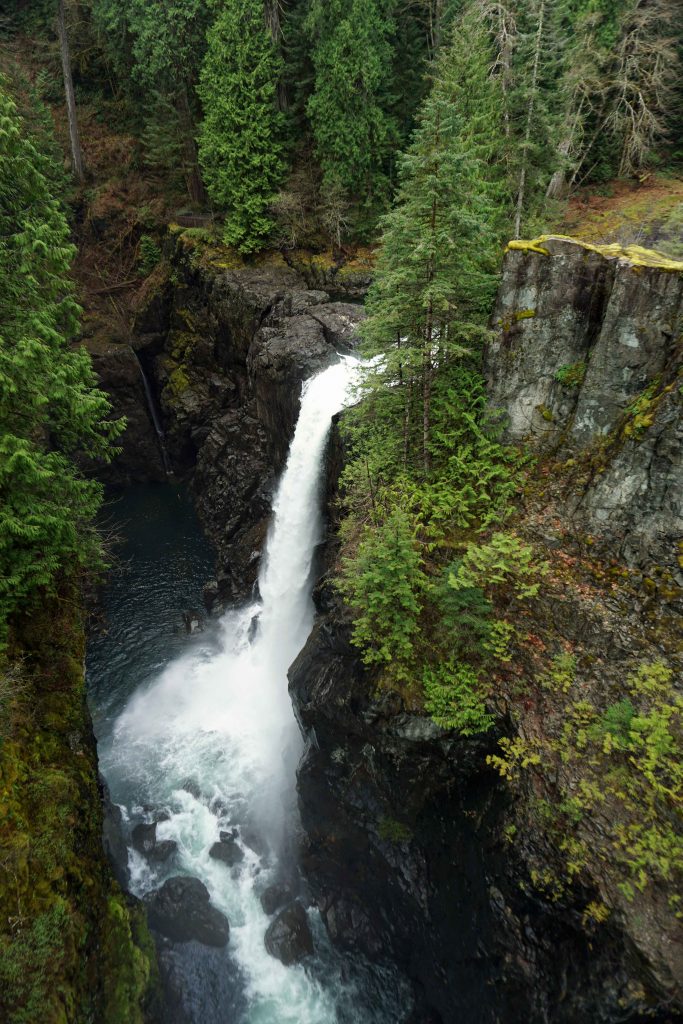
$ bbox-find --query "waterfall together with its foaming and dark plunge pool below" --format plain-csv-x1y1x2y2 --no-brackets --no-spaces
87,359,411,1024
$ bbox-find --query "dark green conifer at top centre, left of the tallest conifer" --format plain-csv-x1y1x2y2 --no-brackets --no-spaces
307,0,398,238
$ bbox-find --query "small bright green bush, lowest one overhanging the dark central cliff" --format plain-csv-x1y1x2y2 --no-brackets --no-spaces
423,662,494,736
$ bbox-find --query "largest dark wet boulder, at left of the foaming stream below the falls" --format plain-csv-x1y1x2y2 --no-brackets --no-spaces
146,877,230,946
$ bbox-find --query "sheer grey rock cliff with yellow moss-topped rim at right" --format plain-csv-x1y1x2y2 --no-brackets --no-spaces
486,237,683,585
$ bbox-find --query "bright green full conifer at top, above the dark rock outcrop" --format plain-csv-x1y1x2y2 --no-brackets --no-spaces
199,0,286,252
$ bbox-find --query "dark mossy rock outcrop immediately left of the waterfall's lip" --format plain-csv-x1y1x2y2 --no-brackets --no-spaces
123,237,364,604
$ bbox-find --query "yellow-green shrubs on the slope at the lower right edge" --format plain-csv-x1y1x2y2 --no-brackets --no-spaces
487,659,683,899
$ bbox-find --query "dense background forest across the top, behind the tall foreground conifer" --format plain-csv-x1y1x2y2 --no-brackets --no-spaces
4,0,683,251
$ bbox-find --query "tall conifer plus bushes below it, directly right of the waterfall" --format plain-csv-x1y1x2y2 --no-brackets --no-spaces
342,13,538,735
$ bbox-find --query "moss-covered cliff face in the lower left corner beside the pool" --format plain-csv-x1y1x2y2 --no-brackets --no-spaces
0,586,156,1024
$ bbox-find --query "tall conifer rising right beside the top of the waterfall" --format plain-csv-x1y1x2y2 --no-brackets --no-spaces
364,11,505,472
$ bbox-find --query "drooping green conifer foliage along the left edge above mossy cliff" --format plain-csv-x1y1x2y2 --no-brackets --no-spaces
0,83,121,643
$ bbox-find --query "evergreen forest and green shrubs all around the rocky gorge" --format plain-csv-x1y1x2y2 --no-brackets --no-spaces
0,0,683,1024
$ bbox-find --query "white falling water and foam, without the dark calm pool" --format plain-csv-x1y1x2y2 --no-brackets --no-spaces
100,357,357,1024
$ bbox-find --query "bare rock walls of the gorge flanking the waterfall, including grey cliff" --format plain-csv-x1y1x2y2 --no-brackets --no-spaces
92,231,683,1024
